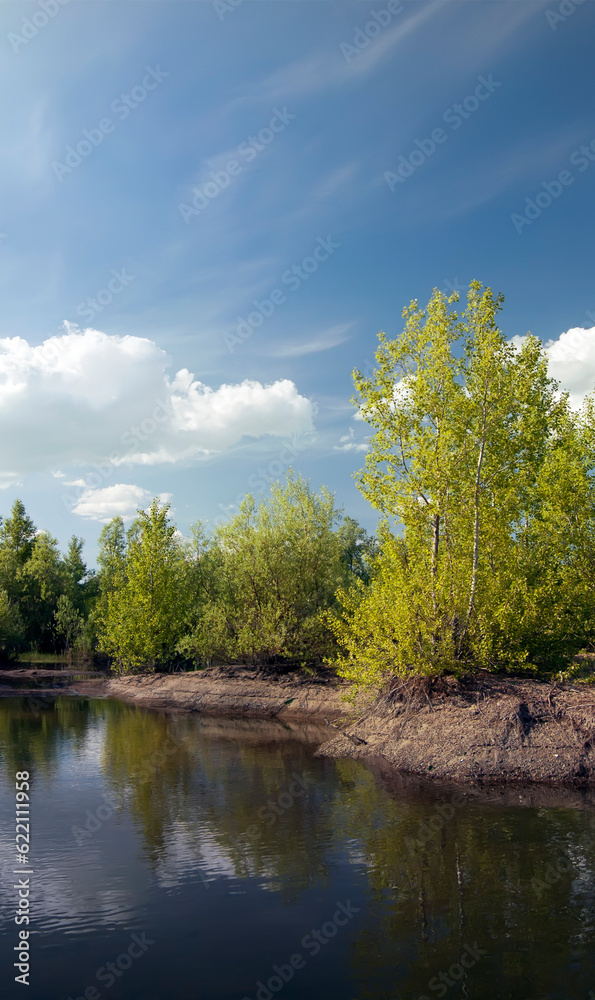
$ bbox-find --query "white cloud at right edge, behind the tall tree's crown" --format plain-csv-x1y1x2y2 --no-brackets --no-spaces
511,326,595,409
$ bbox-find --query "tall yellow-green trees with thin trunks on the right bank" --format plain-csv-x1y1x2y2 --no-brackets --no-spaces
329,282,595,684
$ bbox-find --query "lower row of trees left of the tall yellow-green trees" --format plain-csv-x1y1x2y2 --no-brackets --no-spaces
0,473,376,672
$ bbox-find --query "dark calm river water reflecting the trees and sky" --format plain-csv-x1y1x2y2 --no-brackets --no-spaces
0,696,595,1000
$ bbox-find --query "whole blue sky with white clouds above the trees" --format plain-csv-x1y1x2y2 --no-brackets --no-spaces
0,0,595,561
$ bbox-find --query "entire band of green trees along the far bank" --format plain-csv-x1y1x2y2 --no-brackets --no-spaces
0,282,595,686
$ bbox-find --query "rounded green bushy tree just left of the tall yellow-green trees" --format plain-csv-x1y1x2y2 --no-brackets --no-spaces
179,471,371,664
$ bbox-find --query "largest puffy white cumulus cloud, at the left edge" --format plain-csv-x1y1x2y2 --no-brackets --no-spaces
0,324,314,486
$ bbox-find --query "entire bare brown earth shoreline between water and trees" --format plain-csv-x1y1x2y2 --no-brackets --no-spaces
0,666,595,788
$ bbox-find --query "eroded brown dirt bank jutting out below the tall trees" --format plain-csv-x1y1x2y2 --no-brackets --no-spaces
317,674,595,785
